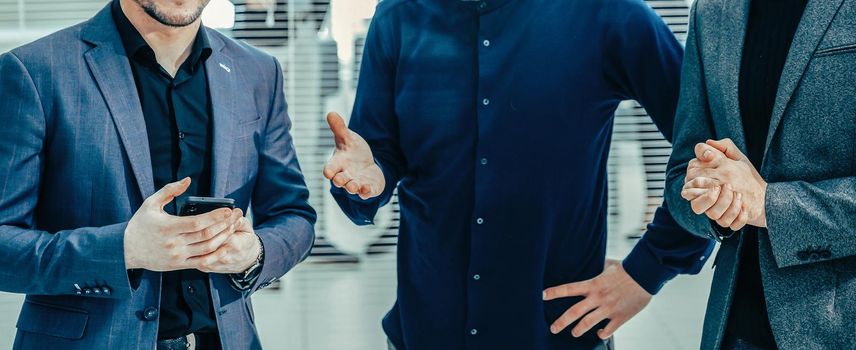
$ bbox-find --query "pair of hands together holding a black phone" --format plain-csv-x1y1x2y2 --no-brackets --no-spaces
124,178,261,273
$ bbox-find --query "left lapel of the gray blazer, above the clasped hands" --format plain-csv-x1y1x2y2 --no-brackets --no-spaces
714,0,750,150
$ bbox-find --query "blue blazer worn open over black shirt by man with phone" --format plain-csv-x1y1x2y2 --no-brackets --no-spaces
0,5,315,349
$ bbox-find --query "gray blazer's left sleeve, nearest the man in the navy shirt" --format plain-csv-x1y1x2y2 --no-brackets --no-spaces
664,3,719,240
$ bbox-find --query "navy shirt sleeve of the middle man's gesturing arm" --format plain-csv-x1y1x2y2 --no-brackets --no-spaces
330,14,407,225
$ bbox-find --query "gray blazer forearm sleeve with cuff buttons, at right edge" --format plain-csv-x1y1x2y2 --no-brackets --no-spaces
765,176,856,268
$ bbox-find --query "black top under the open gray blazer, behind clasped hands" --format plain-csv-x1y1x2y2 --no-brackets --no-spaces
726,0,807,349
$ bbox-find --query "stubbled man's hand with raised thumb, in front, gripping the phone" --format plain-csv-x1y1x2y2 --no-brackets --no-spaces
124,178,244,271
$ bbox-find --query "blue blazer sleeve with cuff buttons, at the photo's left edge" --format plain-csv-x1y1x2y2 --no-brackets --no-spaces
0,52,131,298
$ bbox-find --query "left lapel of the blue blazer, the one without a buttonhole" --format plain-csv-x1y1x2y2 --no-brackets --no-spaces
81,5,155,198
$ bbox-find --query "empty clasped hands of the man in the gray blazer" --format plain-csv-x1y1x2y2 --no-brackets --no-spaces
681,139,767,231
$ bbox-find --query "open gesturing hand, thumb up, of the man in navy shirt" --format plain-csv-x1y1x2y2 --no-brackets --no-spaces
324,112,386,199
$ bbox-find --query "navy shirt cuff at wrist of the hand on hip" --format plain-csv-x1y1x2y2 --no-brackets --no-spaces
621,244,677,295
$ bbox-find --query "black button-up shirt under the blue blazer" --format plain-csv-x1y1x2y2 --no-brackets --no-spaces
112,1,217,339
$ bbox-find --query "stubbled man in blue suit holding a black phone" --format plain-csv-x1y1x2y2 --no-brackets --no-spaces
0,0,316,349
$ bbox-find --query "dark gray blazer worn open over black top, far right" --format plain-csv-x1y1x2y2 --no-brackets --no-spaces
666,0,856,350
